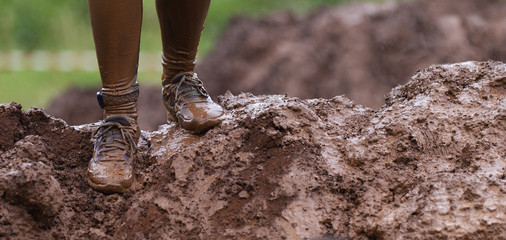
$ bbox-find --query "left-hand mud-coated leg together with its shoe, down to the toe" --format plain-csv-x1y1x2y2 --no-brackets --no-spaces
86,0,142,193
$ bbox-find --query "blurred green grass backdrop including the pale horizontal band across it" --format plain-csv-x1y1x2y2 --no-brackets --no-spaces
0,0,356,109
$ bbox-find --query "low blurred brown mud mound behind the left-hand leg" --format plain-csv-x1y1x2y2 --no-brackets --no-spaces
47,86,167,130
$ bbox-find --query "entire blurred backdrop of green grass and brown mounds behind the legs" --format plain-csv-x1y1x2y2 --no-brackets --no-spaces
0,0,506,130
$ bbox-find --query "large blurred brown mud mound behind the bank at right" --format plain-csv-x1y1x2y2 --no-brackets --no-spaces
198,0,506,108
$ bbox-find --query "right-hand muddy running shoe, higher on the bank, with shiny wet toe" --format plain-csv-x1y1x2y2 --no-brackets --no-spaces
162,72,223,134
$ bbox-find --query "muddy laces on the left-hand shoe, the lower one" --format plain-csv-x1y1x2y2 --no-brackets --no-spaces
95,122,135,162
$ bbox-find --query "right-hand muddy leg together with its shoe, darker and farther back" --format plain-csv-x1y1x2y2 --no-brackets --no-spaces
156,0,223,134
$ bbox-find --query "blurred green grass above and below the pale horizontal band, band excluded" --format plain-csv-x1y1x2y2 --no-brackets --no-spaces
0,0,378,109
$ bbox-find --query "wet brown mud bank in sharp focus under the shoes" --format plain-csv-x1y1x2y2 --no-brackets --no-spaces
0,62,506,239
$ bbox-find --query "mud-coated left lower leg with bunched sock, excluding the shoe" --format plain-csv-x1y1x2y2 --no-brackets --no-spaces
88,0,142,125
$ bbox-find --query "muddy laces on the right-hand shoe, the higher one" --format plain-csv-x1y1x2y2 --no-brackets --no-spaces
170,75,209,106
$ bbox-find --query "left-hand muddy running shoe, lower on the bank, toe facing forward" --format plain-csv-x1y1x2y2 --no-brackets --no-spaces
86,116,136,193
